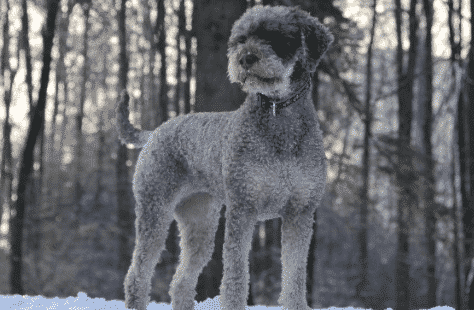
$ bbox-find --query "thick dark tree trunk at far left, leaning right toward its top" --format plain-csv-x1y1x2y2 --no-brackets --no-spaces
10,0,60,295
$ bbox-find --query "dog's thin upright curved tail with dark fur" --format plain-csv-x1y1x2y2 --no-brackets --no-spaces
115,90,153,148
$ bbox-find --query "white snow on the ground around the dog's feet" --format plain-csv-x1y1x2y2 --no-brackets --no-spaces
0,292,454,310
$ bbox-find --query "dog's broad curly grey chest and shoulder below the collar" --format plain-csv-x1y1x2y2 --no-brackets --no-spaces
223,106,326,220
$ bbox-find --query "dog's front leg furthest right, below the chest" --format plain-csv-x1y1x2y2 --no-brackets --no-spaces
278,206,314,310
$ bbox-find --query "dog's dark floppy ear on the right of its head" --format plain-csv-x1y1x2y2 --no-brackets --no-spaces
301,16,334,72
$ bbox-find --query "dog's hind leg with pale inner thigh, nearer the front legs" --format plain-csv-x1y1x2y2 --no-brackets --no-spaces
169,193,221,310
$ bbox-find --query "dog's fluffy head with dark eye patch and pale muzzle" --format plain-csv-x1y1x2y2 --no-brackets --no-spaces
227,5,334,98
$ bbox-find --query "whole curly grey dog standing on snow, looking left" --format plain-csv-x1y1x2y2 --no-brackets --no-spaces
117,6,333,310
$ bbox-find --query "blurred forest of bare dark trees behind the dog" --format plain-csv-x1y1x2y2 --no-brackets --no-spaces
0,0,474,309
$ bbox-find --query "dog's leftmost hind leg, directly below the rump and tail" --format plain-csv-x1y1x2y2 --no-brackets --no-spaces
124,202,173,310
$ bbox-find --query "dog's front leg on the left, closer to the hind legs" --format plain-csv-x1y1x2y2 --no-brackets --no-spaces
220,205,257,310
